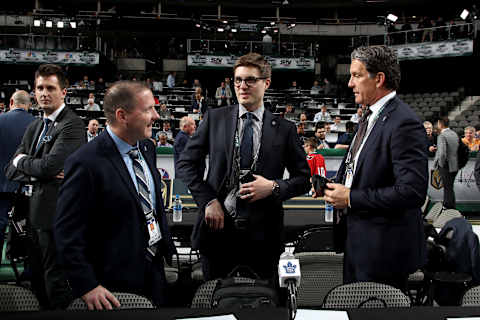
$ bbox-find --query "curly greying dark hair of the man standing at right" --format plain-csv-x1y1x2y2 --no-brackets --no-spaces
350,46,401,90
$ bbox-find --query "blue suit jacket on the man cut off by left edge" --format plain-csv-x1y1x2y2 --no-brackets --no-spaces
0,109,35,192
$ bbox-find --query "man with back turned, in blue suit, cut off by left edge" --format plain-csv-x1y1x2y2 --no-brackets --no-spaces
0,90,34,257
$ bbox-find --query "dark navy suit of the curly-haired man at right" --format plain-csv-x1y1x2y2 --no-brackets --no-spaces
336,97,428,281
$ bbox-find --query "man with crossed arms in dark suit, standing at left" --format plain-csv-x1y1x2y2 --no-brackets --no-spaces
7,64,85,308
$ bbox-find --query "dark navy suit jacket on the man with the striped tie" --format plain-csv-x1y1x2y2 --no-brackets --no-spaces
55,130,176,296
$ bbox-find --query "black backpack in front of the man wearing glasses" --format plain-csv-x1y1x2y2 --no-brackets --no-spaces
212,267,279,309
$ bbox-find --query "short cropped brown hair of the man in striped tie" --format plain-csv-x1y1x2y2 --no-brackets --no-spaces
103,80,150,123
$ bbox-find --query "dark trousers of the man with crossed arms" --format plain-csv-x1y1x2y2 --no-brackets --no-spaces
29,228,73,309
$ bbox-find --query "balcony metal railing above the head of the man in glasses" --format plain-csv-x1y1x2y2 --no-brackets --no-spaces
187,39,314,57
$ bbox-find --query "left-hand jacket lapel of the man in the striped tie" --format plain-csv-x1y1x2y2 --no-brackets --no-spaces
96,130,143,209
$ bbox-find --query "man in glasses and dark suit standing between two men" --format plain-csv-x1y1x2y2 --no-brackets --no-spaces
177,53,310,279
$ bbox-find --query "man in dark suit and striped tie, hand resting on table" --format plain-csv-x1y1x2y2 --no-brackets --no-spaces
55,81,176,309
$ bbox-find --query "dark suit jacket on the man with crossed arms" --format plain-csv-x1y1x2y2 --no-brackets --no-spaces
7,107,85,230
